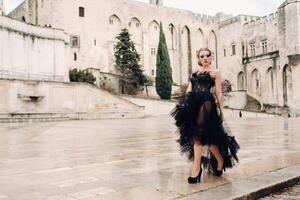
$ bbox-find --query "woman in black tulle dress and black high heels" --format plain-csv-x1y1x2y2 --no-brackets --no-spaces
171,48,239,184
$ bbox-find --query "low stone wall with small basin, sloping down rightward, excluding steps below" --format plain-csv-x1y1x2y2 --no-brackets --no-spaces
0,80,143,115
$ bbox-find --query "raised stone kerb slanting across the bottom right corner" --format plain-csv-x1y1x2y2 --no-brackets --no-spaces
178,165,300,200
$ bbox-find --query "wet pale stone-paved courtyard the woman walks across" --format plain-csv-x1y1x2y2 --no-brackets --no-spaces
0,116,300,200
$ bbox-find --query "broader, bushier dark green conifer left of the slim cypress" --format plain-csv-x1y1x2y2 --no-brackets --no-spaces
114,29,145,94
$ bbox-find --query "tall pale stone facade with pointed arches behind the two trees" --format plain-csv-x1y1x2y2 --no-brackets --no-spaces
8,0,225,84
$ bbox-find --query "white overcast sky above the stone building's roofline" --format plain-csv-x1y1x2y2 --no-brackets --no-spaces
3,0,284,16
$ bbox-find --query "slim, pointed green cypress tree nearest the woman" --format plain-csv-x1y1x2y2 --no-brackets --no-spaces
155,23,173,100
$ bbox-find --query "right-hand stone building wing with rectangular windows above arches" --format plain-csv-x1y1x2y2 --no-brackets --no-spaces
217,0,300,111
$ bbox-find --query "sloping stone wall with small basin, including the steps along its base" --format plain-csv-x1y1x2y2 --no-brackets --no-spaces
0,79,145,123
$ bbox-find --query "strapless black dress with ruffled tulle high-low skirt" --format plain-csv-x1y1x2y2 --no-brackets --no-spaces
171,71,239,170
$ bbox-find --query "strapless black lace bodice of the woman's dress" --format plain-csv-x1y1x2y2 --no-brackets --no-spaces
190,71,215,93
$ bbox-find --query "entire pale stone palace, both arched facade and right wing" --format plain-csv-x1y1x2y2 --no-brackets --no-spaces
8,0,300,110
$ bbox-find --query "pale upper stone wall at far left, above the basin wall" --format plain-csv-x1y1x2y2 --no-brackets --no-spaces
0,16,69,81
